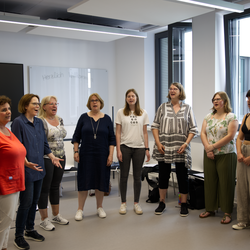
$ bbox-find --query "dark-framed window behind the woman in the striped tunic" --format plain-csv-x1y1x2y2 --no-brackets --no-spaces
155,23,192,108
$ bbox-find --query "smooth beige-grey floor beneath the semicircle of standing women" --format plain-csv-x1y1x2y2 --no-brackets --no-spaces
8,173,250,250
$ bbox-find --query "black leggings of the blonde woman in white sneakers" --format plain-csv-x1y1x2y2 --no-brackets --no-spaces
38,156,66,209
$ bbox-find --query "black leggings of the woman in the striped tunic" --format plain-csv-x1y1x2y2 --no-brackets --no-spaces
158,161,189,194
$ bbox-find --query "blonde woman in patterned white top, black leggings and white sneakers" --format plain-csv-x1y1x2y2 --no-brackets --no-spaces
38,96,69,231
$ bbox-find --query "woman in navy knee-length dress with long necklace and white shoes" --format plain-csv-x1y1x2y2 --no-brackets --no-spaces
72,93,116,221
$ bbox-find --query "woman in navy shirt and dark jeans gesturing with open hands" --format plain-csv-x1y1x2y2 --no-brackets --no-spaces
11,94,63,249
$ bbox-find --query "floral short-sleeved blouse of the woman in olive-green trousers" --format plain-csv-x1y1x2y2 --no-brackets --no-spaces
205,113,237,155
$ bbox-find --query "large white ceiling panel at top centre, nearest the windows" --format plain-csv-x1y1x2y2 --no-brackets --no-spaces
68,0,214,26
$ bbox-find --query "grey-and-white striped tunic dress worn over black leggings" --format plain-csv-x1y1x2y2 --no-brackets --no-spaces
151,102,198,169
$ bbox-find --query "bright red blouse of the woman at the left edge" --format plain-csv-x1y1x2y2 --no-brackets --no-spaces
0,129,26,195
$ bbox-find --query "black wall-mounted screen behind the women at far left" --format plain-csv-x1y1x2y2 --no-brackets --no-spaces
0,63,24,121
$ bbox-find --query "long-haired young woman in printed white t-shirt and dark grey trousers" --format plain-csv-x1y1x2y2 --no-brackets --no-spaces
115,89,150,214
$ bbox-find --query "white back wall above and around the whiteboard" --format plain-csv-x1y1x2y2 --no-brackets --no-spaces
0,32,116,115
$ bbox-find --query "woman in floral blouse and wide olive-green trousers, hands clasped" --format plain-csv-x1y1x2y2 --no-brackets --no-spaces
199,91,238,224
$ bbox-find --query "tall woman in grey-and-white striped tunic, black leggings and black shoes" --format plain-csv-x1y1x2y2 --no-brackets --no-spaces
151,83,198,216
